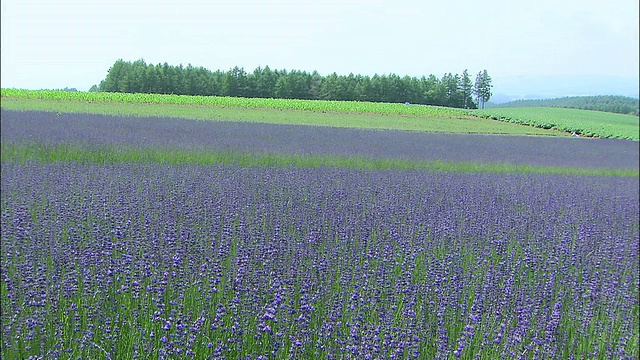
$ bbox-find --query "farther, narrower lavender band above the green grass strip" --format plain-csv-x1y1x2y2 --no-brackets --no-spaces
0,110,640,169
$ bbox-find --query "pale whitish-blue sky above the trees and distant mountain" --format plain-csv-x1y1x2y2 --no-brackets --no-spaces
0,0,640,95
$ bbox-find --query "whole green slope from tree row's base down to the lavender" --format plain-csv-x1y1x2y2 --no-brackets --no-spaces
2,89,567,136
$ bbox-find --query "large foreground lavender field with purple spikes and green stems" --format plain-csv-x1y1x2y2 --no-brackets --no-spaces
0,164,639,359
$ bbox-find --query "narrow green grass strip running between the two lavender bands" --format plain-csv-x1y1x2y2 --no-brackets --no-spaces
1,142,640,177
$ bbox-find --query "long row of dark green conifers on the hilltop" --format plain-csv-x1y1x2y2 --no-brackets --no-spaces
91,59,492,109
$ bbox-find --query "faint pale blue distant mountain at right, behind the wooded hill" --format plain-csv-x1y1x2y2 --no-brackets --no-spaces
488,75,640,105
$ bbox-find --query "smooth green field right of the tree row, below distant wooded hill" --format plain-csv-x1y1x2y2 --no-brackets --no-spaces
474,107,640,141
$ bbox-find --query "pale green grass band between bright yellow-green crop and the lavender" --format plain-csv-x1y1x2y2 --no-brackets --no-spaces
2,98,566,136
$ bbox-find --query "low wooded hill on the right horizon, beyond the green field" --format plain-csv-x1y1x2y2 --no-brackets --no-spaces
491,95,640,116
